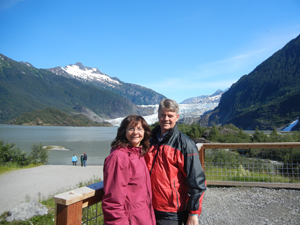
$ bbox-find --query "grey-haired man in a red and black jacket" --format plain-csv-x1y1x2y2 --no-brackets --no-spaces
145,99,206,225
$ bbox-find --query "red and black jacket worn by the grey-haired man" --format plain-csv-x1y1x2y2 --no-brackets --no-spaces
145,124,206,218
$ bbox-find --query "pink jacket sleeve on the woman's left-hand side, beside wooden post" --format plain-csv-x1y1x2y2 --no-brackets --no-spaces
102,152,129,225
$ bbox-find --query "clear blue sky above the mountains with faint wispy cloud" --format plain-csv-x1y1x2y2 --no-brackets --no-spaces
0,0,300,103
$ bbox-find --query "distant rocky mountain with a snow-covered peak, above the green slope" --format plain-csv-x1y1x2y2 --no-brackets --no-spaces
49,62,165,105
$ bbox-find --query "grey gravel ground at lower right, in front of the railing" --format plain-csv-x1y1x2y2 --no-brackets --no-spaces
199,187,300,225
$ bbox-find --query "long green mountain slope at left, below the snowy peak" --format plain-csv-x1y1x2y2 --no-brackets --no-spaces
0,54,138,123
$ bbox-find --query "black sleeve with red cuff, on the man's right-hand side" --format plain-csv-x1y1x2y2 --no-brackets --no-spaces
184,140,206,215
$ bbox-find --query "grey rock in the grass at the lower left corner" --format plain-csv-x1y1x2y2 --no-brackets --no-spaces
5,201,48,222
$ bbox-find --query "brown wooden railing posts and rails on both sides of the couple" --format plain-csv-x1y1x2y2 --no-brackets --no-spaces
54,142,300,225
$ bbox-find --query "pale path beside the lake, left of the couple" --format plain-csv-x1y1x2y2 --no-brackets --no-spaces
0,165,103,215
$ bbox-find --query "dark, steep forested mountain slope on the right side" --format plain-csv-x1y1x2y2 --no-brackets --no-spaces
201,35,300,129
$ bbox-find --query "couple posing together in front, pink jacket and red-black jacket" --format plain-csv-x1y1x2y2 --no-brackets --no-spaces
102,99,206,225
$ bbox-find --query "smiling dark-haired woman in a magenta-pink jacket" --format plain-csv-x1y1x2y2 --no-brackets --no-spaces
102,115,155,225
